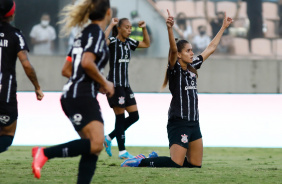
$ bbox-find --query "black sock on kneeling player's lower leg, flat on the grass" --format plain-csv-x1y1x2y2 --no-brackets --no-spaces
139,157,181,168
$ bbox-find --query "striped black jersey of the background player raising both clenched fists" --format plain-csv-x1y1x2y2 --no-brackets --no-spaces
108,37,139,87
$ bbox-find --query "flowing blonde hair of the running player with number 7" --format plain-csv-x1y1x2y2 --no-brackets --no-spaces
58,0,95,36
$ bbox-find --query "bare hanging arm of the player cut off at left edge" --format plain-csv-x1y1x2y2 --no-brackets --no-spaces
18,50,44,100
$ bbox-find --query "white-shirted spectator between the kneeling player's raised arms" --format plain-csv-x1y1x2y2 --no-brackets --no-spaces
193,25,211,53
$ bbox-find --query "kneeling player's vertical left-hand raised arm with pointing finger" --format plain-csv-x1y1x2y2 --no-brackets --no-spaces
166,10,177,69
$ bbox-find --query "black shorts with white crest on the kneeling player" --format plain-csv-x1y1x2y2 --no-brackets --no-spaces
167,119,202,148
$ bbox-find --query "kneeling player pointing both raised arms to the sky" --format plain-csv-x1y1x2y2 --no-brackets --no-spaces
121,11,233,168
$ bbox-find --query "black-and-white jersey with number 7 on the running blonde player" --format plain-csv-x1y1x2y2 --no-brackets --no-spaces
63,24,109,98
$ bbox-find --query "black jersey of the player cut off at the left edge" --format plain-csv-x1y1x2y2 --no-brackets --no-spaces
0,23,29,103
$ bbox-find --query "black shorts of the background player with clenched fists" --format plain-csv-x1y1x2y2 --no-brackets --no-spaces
108,86,136,108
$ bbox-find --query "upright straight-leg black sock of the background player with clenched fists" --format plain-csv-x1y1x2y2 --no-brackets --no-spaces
115,113,125,151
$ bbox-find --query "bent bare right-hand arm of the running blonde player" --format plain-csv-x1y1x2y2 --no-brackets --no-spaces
81,52,114,97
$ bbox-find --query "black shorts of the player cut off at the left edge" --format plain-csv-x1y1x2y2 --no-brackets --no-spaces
0,101,18,126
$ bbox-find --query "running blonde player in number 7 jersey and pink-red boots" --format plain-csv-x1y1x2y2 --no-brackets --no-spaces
32,0,114,183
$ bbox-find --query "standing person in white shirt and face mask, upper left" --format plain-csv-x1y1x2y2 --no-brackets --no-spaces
29,14,56,55
